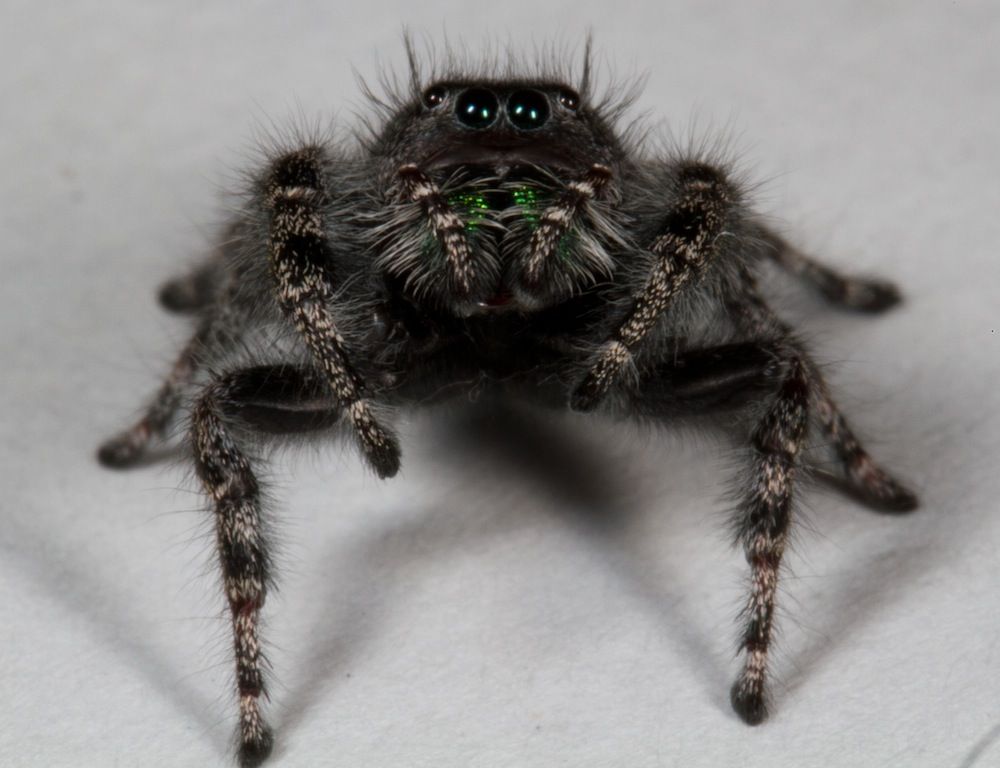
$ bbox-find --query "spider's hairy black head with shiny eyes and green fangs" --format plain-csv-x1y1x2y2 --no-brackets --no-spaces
374,78,625,316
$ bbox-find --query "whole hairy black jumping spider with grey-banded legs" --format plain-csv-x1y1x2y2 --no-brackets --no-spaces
98,43,917,766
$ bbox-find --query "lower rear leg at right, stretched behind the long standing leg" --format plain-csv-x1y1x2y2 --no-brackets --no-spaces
731,284,918,512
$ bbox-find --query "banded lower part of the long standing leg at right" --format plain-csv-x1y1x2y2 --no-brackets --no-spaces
731,350,810,725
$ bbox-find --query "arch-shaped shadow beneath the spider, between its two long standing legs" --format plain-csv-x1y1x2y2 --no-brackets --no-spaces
275,404,730,743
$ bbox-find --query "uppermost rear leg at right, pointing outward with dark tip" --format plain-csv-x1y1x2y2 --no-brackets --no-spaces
764,229,903,313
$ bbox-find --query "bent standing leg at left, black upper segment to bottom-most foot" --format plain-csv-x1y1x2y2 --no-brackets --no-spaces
191,366,341,766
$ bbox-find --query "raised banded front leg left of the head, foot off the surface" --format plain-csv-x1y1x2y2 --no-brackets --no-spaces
268,148,399,477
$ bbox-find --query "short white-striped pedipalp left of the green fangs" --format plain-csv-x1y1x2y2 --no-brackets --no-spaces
398,163,477,299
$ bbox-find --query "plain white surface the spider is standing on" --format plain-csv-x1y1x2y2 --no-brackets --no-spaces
0,0,1000,768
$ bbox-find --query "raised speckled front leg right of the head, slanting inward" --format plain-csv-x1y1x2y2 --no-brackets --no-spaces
570,165,731,411
